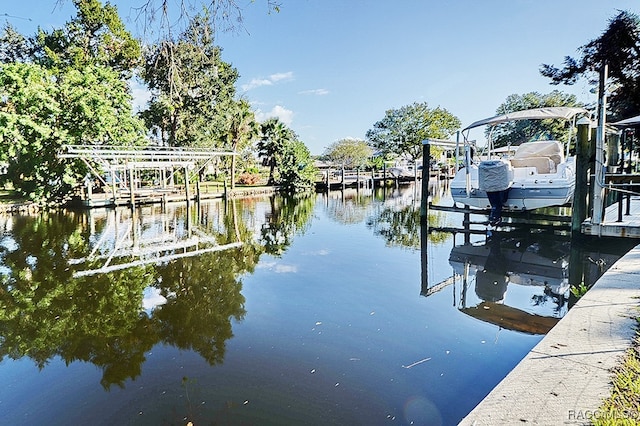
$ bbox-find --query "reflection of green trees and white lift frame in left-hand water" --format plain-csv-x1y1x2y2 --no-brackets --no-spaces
0,197,314,389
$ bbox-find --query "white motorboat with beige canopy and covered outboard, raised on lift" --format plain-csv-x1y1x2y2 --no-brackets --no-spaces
451,107,589,224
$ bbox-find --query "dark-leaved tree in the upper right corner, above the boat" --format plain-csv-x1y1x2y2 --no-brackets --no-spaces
540,11,640,119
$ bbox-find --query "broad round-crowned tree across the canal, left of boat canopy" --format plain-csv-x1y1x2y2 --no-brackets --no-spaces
366,102,460,162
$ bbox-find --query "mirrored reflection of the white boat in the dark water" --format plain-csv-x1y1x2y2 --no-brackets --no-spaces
449,234,570,334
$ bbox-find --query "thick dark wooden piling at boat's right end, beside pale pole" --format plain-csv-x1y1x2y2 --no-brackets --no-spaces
571,117,591,236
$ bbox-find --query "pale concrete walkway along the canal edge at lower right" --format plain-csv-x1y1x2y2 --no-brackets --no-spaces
460,246,640,426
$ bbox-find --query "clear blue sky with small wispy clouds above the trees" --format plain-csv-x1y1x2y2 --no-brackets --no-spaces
0,0,640,155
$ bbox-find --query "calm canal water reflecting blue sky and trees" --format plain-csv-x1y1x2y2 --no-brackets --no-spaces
0,186,626,425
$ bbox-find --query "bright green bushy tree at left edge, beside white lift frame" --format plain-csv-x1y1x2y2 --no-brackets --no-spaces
0,63,143,202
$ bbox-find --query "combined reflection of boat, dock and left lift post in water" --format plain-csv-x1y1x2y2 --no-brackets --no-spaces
421,224,637,334
